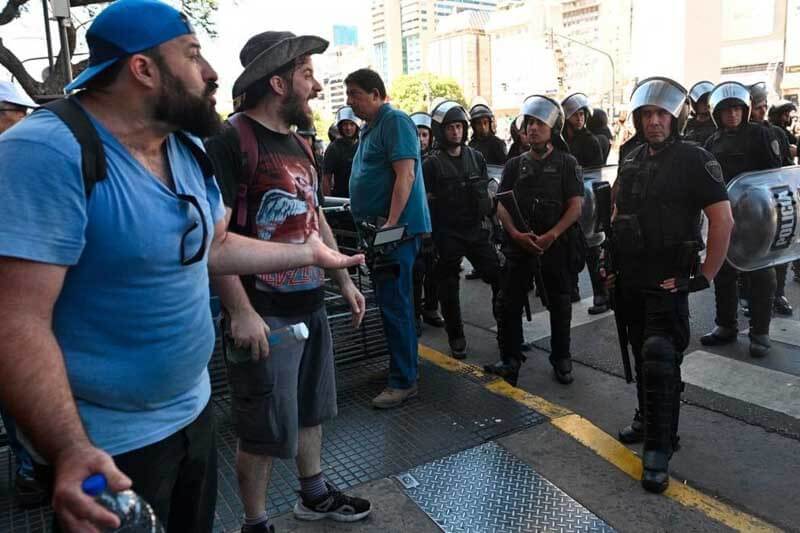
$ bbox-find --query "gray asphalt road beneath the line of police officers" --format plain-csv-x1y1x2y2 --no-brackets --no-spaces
420,258,800,530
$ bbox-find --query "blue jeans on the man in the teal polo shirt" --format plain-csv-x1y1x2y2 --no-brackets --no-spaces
375,237,420,389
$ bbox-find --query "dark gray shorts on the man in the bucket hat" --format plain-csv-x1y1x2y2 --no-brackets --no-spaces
227,307,336,459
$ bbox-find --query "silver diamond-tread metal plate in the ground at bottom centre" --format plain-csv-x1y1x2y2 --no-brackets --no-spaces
405,442,614,533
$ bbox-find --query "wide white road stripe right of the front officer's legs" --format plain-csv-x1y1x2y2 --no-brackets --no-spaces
681,350,800,419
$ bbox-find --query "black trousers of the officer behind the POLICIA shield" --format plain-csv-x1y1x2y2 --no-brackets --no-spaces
714,263,776,335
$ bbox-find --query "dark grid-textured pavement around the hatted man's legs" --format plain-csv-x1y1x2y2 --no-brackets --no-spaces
0,359,545,533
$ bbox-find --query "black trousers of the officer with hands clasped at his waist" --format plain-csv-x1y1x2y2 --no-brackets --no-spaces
497,241,574,363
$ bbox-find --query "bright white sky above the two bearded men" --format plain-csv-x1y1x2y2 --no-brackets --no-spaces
0,0,370,111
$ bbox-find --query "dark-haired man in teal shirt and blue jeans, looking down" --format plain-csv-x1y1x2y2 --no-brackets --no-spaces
345,69,431,409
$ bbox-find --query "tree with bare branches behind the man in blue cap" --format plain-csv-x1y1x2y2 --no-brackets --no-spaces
0,0,217,98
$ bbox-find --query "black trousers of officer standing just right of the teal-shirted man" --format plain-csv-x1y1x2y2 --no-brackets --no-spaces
433,224,500,339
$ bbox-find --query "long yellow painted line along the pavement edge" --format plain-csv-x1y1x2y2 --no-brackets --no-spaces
419,342,781,533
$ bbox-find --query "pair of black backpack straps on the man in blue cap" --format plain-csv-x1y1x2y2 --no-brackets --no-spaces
39,97,214,199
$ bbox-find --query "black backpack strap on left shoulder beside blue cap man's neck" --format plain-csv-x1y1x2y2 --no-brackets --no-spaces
40,98,106,199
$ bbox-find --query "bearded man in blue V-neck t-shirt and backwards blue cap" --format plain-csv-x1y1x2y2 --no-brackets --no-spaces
0,0,363,532
